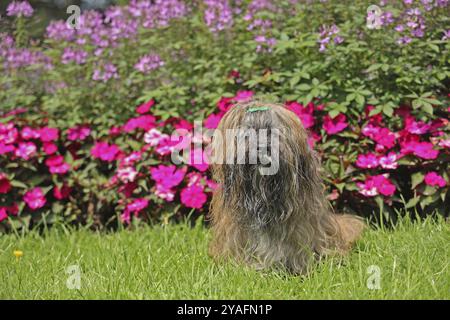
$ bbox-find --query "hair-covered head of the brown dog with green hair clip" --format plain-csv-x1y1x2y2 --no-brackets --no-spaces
212,102,320,229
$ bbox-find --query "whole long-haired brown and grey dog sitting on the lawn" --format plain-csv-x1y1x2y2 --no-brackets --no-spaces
210,101,364,274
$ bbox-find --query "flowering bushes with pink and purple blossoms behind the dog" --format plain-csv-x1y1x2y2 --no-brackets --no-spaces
0,0,450,227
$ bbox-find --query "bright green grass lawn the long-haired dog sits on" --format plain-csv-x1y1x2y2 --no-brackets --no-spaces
0,219,450,299
